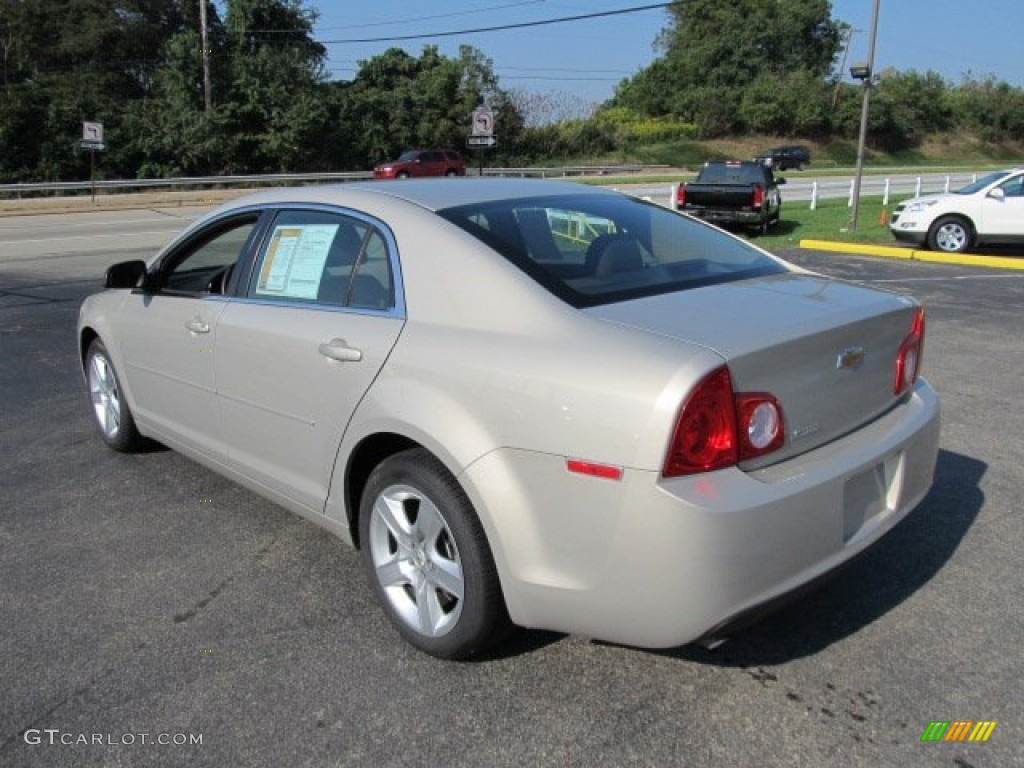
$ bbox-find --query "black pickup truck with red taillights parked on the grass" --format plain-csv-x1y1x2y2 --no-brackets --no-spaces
674,161,785,234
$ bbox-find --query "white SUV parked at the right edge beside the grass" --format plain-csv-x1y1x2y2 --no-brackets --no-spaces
889,168,1024,253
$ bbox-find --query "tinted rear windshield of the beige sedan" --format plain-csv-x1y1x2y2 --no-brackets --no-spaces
438,195,785,307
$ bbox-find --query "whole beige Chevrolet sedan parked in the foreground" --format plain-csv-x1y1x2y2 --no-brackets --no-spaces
78,179,939,658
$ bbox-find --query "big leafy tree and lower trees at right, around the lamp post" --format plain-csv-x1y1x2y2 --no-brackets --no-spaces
611,0,1024,153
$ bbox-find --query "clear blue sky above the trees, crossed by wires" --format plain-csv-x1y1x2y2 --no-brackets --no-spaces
307,0,1024,109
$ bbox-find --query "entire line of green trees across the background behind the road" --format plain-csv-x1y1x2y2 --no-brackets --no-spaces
0,0,1024,182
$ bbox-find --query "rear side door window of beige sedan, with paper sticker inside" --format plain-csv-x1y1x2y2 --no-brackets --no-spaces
249,211,394,310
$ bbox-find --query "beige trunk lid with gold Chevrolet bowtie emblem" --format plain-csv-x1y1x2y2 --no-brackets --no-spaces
585,273,916,468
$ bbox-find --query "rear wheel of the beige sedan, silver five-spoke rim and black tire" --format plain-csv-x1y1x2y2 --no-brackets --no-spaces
359,449,511,658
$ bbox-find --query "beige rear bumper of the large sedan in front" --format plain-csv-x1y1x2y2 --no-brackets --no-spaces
461,381,940,647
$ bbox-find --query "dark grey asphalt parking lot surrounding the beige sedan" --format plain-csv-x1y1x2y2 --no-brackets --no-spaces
0,208,1024,768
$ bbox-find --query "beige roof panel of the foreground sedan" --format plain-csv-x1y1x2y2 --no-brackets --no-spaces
204,177,615,213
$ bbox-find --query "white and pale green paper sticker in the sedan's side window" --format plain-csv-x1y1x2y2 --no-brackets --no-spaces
256,224,338,301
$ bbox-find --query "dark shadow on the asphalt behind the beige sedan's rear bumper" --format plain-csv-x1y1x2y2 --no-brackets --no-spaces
634,451,987,667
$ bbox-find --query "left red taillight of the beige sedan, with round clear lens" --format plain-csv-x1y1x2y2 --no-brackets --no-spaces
663,366,785,477
